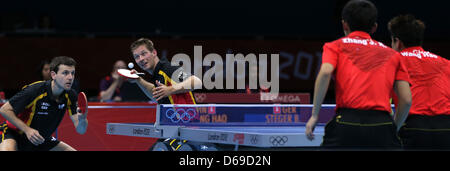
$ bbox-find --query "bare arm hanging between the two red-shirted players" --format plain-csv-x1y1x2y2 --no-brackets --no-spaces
394,80,412,131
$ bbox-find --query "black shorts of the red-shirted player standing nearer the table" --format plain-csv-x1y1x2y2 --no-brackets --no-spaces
322,108,401,149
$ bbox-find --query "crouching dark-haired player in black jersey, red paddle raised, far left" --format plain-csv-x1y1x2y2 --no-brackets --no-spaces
0,56,88,151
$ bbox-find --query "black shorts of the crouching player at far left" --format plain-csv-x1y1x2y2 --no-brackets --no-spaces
0,124,60,151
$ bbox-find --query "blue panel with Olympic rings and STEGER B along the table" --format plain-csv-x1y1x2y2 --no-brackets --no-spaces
159,104,334,126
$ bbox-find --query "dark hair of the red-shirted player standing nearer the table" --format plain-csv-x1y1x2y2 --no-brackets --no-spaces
342,0,378,33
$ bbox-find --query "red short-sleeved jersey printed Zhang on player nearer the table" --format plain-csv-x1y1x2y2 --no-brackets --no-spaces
322,31,409,112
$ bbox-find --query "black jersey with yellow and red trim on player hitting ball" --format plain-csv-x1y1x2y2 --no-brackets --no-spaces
150,60,195,104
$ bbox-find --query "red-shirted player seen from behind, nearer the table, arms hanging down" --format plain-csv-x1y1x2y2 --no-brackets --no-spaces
305,0,411,148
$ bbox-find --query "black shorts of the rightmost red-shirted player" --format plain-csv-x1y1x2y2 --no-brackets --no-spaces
399,115,450,150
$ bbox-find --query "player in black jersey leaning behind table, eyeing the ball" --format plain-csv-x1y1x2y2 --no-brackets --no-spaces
129,38,202,104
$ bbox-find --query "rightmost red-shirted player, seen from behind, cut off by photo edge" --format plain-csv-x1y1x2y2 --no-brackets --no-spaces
388,15,450,149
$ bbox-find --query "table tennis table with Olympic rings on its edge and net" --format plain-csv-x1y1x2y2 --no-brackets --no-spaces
106,104,335,151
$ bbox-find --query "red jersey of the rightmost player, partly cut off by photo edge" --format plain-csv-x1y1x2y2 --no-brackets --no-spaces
400,46,450,116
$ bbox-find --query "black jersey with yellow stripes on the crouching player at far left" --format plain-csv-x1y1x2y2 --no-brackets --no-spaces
6,81,77,139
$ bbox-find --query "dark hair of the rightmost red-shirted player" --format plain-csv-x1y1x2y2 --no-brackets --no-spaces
388,14,425,47
